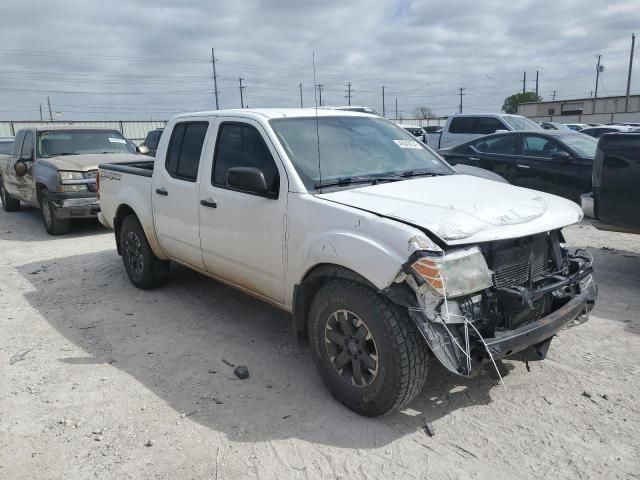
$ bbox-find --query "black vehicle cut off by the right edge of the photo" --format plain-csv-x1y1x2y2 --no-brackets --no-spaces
582,133,640,234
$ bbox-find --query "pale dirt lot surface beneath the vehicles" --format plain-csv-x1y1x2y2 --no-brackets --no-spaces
0,209,640,480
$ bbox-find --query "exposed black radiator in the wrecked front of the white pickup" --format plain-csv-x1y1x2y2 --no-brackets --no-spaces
488,234,549,288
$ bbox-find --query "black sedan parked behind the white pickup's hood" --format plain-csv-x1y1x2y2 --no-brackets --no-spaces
441,130,597,204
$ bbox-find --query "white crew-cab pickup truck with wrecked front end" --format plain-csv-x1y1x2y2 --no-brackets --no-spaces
98,109,597,416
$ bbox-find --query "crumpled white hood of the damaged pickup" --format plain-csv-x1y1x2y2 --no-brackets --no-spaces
317,175,582,245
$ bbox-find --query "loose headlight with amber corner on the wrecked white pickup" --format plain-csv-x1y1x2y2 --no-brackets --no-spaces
412,247,493,297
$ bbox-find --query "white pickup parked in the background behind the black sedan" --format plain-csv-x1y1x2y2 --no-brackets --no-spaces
427,113,542,150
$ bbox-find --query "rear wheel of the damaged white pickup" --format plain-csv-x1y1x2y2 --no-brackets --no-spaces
119,215,169,289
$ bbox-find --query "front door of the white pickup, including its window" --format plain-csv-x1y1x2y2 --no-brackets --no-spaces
200,118,288,304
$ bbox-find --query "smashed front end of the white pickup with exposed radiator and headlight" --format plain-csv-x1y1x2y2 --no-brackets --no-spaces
387,230,597,376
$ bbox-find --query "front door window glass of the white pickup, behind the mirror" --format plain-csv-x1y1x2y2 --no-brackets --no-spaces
211,123,280,192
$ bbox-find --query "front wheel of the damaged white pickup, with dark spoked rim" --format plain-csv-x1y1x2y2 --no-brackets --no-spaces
308,279,428,417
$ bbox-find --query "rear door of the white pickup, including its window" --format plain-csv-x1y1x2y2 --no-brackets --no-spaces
151,121,209,269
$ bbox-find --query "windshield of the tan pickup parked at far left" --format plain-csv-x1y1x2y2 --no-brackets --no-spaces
37,129,135,158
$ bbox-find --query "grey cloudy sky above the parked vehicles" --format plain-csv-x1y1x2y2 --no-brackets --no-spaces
0,0,640,120
